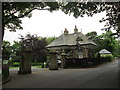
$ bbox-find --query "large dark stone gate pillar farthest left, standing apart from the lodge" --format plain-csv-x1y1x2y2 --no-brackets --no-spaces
18,48,32,74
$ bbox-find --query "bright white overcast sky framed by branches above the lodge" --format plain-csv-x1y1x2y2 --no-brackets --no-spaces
4,10,106,43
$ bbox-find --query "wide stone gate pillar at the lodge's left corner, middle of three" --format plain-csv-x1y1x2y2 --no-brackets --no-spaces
49,51,58,70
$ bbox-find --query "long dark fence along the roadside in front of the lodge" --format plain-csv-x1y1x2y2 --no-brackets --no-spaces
65,57,113,67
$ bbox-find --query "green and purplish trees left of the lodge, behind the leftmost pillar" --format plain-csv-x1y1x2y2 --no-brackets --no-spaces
2,34,56,64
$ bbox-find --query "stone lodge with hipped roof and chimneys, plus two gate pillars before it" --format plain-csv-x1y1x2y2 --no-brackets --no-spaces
47,26,97,69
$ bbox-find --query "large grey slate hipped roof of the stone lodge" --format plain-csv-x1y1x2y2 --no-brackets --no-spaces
47,32,96,48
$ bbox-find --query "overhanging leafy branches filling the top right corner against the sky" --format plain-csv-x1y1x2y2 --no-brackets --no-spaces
61,0,120,36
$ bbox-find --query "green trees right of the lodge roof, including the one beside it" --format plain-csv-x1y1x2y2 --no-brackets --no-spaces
86,31,120,56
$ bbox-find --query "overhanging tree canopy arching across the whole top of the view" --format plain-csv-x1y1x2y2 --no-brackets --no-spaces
2,2,120,40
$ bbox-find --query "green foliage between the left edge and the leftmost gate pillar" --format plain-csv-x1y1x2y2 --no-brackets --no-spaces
2,41,21,66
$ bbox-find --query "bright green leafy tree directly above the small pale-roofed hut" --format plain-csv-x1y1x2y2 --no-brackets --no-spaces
94,31,120,56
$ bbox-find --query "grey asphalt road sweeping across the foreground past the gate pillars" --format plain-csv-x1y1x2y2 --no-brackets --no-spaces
3,60,118,88
